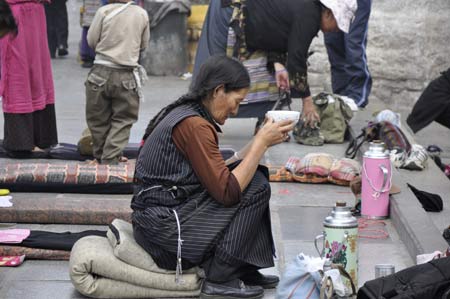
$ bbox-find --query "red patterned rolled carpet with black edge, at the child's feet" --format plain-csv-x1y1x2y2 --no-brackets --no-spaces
0,159,135,194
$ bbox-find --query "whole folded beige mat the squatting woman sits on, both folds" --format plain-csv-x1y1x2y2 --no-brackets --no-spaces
69,219,202,298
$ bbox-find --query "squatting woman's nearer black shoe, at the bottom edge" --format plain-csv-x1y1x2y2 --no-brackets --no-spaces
200,279,264,299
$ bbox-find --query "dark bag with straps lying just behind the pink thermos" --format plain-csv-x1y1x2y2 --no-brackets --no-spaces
345,121,411,159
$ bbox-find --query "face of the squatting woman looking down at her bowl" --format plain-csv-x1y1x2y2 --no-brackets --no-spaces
204,85,248,125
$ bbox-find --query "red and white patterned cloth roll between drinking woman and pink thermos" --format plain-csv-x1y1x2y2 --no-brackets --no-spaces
269,153,361,186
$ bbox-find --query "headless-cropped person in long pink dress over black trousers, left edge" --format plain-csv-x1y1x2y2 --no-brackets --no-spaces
0,0,58,157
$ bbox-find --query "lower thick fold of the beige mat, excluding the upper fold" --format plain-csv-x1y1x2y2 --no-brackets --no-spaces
69,236,202,298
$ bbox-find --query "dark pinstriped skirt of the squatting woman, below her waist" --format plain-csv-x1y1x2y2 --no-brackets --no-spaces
131,170,275,270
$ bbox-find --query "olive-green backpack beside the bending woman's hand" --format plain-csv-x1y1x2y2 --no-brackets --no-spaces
313,92,353,143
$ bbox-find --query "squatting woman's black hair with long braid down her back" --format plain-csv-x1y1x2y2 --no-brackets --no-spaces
142,55,250,141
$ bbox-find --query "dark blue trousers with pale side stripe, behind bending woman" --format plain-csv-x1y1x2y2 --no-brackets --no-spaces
324,0,372,107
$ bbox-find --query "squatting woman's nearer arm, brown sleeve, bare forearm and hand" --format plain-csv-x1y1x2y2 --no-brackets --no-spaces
172,117,293,206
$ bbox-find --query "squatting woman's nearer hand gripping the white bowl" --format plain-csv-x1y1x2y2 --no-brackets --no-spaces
255,118,294,148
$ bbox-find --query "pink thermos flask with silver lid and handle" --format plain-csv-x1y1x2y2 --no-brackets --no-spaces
361,141,392,219
